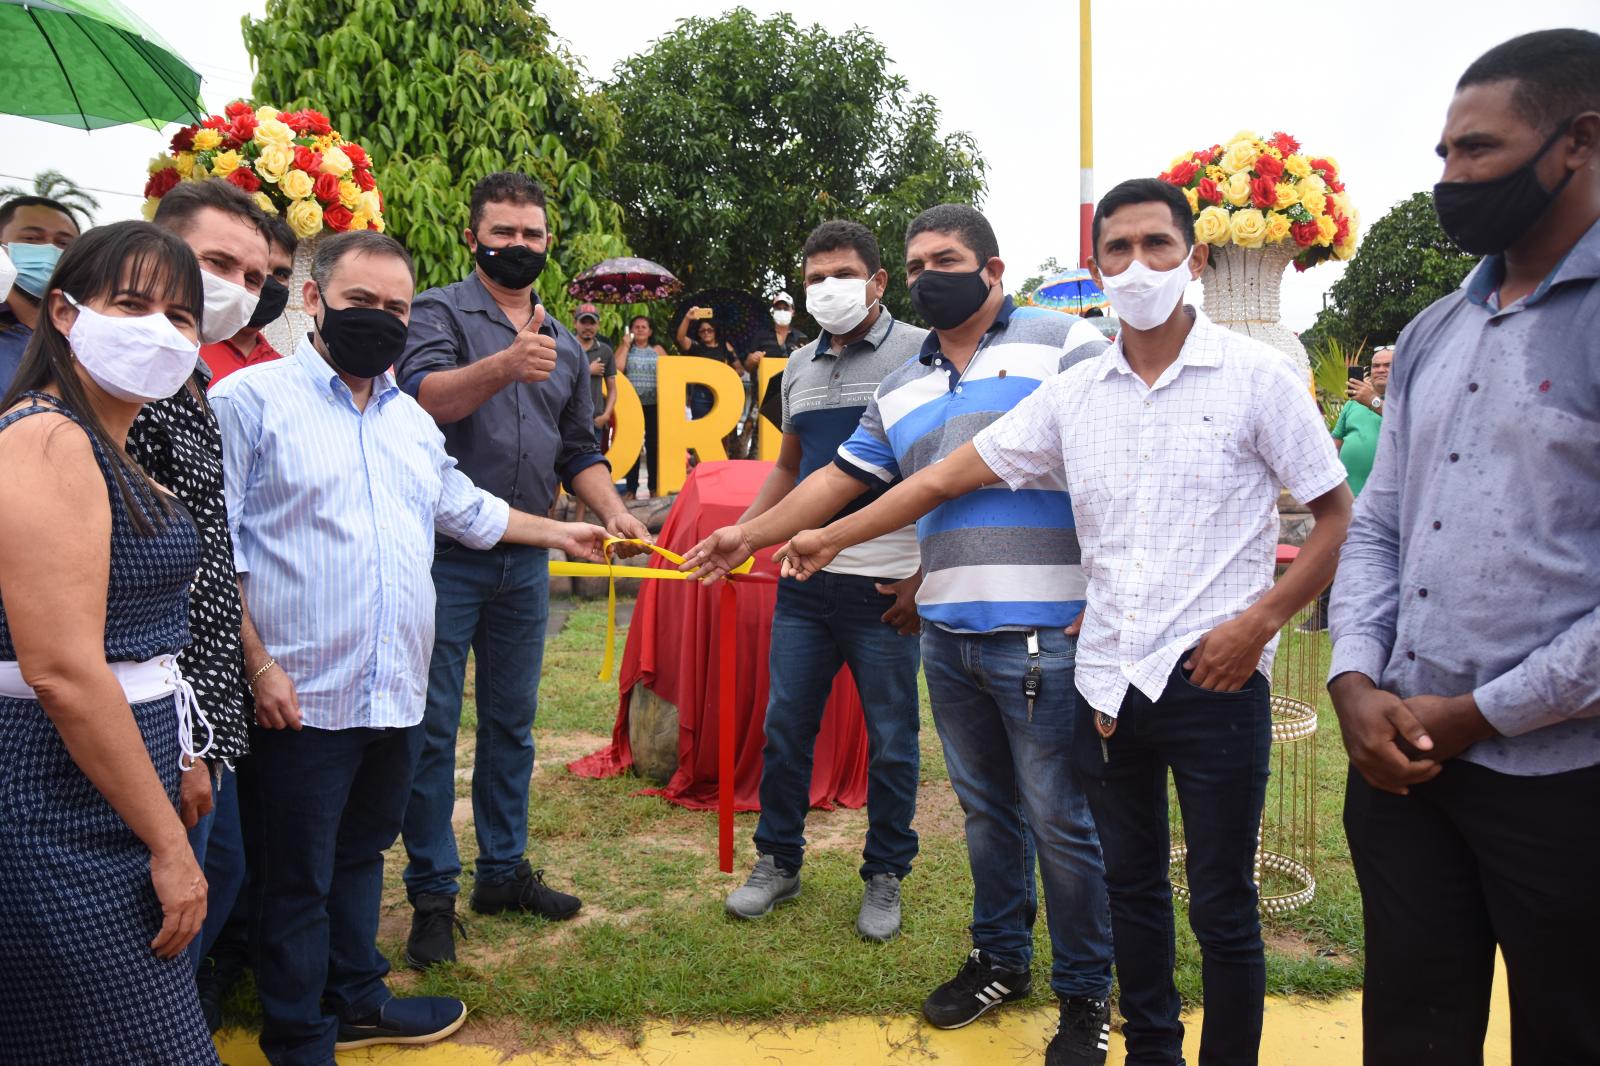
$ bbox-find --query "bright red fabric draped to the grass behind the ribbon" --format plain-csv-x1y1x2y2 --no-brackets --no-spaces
566,461,867,810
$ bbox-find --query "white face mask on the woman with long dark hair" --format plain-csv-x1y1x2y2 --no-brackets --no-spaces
62,293,200,403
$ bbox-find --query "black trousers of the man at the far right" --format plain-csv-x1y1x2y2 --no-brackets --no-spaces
1344,759,1600,1066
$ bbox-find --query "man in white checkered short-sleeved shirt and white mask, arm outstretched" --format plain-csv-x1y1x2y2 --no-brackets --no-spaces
782,179,1350,1066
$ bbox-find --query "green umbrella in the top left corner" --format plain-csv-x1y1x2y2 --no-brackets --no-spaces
0,0,206,130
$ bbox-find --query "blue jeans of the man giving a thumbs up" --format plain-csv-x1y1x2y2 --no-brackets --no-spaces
405,541,550,901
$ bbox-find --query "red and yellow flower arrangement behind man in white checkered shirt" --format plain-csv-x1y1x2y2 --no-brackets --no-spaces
1160,130,1357,271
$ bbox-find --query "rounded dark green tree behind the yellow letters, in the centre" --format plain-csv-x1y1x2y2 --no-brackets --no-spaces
606,8,984,315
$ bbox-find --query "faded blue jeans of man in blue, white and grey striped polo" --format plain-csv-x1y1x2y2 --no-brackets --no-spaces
922,626,1110,999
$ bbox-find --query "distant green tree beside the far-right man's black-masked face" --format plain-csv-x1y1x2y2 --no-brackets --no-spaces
1301,192,1477,347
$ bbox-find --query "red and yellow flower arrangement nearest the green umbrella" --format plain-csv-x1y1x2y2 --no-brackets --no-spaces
144,101,384,240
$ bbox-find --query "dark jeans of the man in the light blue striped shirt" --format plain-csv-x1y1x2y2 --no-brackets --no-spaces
250,725,422,1066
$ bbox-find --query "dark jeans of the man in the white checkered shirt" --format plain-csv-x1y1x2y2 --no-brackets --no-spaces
1075,661,1272,1066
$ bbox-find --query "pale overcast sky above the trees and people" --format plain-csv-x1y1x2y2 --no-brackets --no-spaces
0,0,1600,330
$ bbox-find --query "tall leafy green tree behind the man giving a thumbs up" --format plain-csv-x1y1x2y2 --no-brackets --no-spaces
245,0,627,320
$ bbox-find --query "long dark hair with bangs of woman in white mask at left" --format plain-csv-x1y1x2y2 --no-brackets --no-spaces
0,222,205,535
